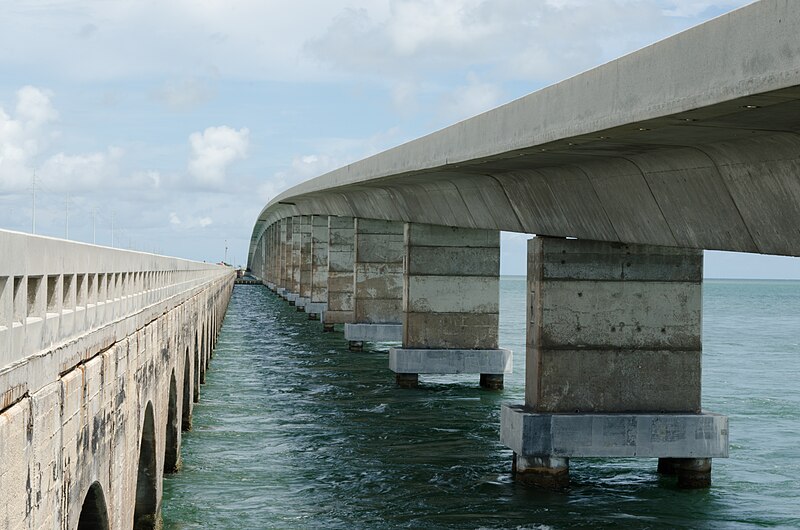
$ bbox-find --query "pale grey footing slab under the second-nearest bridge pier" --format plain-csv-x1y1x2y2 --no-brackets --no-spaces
389,348,513,376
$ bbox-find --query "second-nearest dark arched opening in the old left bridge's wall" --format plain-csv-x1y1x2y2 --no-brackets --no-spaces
133,401,158,530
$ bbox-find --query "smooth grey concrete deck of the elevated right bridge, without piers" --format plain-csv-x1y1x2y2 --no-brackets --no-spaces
250,0,800,268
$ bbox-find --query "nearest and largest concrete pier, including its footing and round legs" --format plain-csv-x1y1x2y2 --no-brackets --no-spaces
501,237,728,487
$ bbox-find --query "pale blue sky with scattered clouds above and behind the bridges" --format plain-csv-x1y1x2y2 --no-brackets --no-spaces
0,0,800,278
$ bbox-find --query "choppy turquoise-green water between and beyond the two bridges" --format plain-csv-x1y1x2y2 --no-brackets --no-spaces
163,277,800,530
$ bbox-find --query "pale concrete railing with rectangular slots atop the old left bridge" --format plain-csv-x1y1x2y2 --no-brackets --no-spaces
0,230,233,391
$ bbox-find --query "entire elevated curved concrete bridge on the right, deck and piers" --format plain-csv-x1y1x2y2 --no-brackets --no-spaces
249,0,800,487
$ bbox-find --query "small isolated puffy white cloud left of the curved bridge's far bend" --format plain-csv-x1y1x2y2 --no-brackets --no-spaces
188,125,250,187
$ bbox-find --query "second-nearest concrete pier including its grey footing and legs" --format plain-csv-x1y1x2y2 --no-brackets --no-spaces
389,223,512,388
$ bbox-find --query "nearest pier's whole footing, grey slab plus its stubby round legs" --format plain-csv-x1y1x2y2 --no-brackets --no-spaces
500,405,728,489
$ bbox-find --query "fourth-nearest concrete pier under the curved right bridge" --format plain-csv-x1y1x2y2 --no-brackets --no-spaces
322,216,355,331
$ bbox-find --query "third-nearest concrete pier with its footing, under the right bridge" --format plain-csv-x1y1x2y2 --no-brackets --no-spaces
344,219,405,351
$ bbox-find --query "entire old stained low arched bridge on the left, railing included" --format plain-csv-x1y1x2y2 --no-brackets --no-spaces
0,231,234,529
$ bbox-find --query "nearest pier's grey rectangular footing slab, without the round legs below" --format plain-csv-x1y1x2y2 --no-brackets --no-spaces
500,405,728,458
